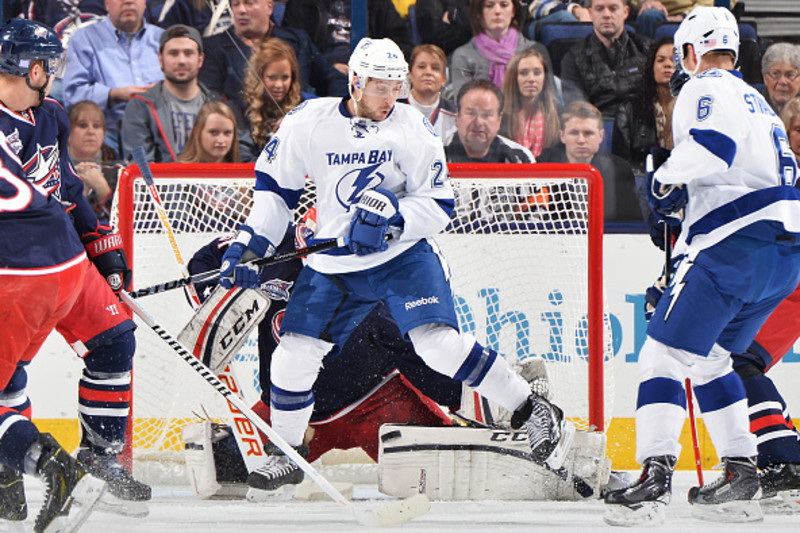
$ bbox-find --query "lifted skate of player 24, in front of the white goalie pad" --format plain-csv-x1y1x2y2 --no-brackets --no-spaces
511,393,575,470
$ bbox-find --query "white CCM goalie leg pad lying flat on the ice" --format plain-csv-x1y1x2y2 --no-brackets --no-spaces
378,425,611,500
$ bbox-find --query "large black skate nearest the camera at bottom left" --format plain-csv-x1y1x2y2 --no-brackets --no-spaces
25,433,106,533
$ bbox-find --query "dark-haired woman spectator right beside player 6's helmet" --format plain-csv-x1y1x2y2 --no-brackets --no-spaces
611,37,675,176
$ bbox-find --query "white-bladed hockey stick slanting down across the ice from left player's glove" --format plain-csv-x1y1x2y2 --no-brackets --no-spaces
120,291,430,526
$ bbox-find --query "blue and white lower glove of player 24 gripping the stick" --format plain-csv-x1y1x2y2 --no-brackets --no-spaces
219,224,275,289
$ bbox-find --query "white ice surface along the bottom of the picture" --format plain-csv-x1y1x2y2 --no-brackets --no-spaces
7,472,800,533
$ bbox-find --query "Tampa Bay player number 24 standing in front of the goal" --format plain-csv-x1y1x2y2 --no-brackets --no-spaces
220,38,574,489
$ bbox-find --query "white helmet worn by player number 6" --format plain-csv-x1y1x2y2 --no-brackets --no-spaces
674,6,739,75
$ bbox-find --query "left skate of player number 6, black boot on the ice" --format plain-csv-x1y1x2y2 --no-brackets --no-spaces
603,455,677,526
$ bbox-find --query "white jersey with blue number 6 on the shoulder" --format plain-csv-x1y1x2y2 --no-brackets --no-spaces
655,69,800,253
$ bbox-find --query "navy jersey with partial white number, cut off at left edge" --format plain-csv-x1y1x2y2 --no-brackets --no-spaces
0,128,85,270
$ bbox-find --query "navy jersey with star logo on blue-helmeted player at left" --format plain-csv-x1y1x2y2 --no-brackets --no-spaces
0,98,98,235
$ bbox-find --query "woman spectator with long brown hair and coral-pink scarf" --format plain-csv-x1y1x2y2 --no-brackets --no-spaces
501,47,560,157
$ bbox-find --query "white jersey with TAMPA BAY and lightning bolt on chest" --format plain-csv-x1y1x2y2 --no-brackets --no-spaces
247,94,454,273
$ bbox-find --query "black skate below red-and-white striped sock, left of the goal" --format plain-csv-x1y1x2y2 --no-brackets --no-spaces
76,447,152,517
